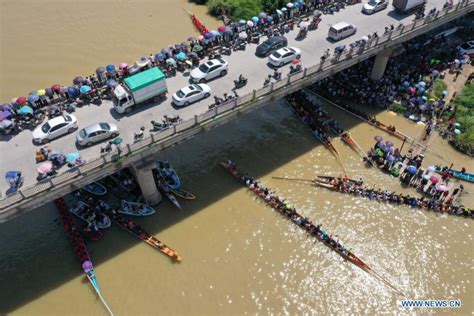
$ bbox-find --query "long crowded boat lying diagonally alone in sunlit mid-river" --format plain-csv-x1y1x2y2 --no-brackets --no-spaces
221,161,372,273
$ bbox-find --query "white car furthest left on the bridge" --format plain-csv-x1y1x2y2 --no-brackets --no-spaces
33,114,79,144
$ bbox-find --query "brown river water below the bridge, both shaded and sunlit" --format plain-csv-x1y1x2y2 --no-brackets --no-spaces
0,97,474,315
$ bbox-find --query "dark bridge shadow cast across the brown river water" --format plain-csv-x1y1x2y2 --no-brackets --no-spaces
0,95,388,314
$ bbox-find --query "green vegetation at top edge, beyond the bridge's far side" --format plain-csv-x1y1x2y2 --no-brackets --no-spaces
194,0,288,20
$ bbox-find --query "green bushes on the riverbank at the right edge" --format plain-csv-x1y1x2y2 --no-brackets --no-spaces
451,84,474,153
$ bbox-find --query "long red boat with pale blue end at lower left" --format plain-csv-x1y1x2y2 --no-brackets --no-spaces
54,198,113,315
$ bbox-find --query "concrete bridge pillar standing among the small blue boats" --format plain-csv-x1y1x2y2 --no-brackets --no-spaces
132,160,162,205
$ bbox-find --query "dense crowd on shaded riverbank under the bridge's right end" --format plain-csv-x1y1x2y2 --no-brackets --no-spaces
311,18,472,118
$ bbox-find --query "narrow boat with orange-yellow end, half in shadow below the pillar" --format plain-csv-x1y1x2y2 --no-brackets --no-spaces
108,211,182,262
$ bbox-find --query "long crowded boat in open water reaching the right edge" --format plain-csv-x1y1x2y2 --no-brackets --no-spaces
313,176,474,217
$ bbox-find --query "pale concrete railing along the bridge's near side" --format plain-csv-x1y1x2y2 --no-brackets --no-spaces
0,0,474,210
